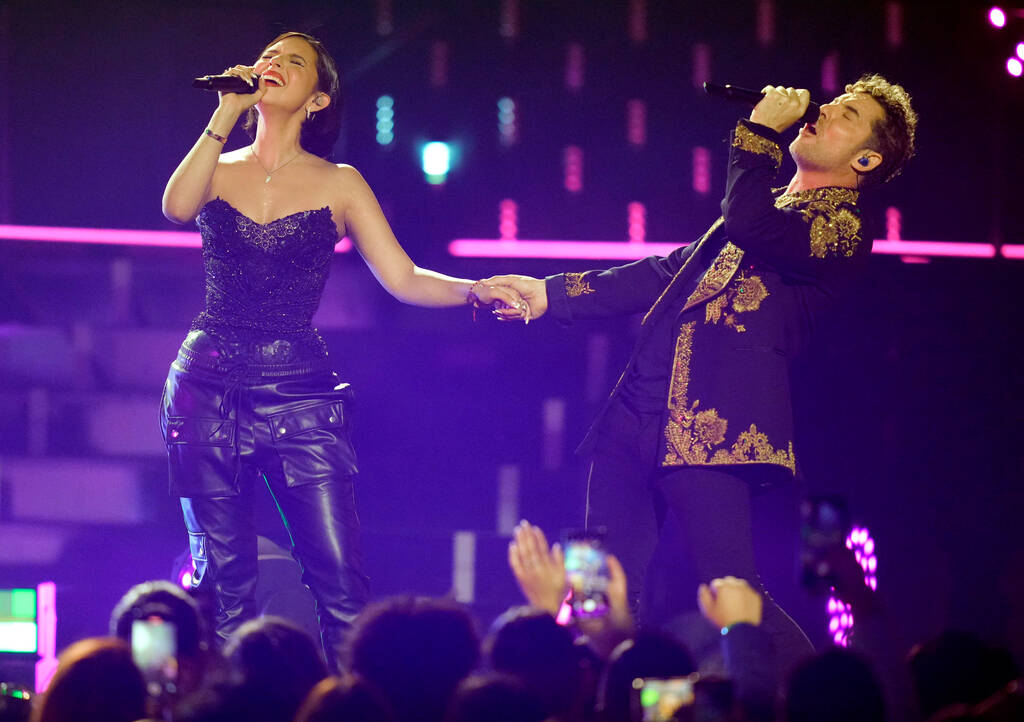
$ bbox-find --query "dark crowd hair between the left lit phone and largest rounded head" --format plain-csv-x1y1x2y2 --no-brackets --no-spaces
224,617,328,720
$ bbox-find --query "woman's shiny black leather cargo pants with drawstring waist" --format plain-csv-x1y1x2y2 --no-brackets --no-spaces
161,337,369,671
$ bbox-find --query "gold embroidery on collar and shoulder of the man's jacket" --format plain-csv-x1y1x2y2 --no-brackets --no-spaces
775,187,860,258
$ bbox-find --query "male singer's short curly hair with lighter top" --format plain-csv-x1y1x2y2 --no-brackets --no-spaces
846,75,918,187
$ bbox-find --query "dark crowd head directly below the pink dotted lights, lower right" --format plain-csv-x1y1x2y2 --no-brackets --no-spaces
785,649,886,722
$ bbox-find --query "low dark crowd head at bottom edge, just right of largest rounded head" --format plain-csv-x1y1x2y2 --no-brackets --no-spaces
445,673,549,722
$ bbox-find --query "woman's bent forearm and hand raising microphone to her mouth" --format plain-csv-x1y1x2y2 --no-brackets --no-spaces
163,66,266,223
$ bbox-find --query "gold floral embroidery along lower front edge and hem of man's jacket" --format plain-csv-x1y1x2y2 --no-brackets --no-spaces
662,321,797,472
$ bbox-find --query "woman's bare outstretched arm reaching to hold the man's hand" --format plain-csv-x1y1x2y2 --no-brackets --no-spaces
337,165,526,311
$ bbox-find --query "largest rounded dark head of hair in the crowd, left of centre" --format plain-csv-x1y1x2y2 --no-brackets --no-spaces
350,597,479,722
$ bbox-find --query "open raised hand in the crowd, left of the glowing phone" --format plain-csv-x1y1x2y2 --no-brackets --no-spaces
509,518,568,615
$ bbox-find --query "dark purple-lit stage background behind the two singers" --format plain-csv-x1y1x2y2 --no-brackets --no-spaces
0,0,1024,680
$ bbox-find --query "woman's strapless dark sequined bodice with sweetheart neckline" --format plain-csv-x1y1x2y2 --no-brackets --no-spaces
191,198,338,355
